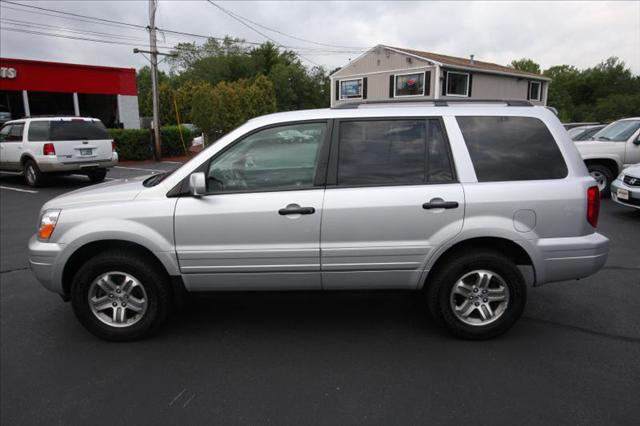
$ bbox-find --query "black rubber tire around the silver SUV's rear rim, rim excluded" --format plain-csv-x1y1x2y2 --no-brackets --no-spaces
426,251,527,340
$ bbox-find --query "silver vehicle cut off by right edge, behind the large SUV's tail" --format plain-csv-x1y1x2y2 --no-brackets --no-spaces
575,117,640,197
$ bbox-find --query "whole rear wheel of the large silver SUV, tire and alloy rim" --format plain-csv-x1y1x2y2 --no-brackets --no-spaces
427,252,527,339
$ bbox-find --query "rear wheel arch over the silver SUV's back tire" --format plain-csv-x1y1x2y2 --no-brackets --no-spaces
421,236,537,288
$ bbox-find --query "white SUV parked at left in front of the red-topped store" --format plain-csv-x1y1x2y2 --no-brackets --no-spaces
0,117,118,186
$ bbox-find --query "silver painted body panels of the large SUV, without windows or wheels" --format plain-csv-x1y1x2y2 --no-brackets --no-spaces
30,105,608,293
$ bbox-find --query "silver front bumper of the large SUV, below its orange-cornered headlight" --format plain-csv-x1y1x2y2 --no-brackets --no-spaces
29,235,65,294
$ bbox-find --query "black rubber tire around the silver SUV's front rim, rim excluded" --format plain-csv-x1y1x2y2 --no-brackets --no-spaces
71,250,171,341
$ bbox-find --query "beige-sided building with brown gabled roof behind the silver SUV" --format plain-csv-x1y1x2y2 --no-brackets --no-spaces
331,45,550,107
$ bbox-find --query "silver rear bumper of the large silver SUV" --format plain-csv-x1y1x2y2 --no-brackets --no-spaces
536,232,609,285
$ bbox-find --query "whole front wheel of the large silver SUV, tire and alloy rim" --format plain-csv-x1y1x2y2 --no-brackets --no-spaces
71,252,170,341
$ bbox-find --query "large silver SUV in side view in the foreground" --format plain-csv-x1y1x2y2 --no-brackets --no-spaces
29,101,609,340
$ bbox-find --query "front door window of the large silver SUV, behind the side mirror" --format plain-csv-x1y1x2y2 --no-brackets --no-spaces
207,123,326,192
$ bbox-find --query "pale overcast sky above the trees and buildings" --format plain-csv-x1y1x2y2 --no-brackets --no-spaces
0,0,640,75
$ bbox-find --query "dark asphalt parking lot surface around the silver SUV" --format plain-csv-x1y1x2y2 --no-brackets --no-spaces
0,163,640,425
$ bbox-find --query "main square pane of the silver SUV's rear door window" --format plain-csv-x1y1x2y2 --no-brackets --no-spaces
338,120,426,185
